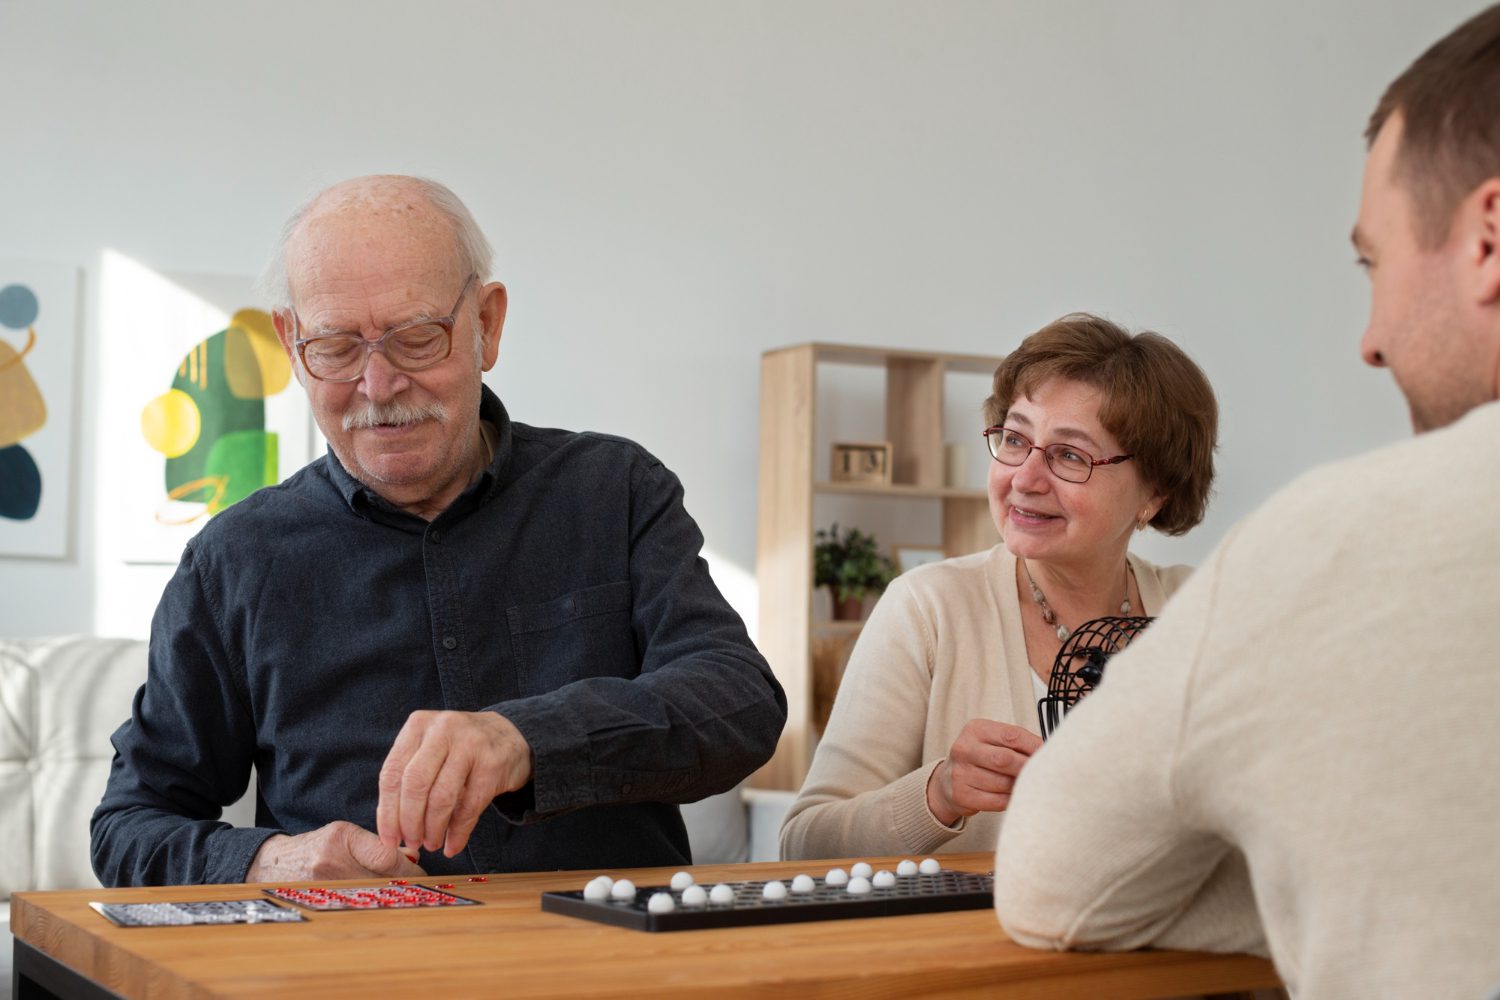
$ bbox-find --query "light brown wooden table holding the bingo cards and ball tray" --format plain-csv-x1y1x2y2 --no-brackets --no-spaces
11,853,1278,1000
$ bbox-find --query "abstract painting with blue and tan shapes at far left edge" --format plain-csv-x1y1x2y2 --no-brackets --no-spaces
0,256,78,559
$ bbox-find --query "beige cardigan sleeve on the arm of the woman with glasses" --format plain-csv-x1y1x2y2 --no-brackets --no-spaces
782,579,963,859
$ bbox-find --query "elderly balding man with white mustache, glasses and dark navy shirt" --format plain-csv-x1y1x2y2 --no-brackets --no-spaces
92,177,786,885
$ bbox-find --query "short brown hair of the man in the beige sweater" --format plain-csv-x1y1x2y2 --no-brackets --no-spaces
1365,4,1500,249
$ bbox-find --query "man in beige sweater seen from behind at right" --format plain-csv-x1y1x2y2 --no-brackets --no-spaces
995,6,1500,1000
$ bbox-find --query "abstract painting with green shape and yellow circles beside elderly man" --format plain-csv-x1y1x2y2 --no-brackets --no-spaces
102,255,312,562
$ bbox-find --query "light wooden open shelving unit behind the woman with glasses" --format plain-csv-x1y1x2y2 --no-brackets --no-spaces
755,343,1001,789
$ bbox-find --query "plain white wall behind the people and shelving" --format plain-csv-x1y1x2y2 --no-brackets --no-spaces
0,0,1476,636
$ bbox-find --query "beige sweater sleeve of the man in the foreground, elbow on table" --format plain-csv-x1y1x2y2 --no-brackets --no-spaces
995,535,1265,954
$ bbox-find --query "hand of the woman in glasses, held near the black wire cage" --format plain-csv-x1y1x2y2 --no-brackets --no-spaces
927,718,1041,826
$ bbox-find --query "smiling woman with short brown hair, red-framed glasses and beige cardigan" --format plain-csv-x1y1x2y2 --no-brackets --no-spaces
782,313,1218,859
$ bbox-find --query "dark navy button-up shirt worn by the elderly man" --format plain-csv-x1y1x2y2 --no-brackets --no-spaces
92,388,786,885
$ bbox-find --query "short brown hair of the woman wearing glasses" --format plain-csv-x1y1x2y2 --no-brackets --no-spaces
984,312,1218,535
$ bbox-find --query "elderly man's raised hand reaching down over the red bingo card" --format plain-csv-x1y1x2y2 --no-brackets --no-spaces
375,712,531,858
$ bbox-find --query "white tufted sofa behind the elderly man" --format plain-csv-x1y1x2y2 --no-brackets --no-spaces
0,636,792,1000
